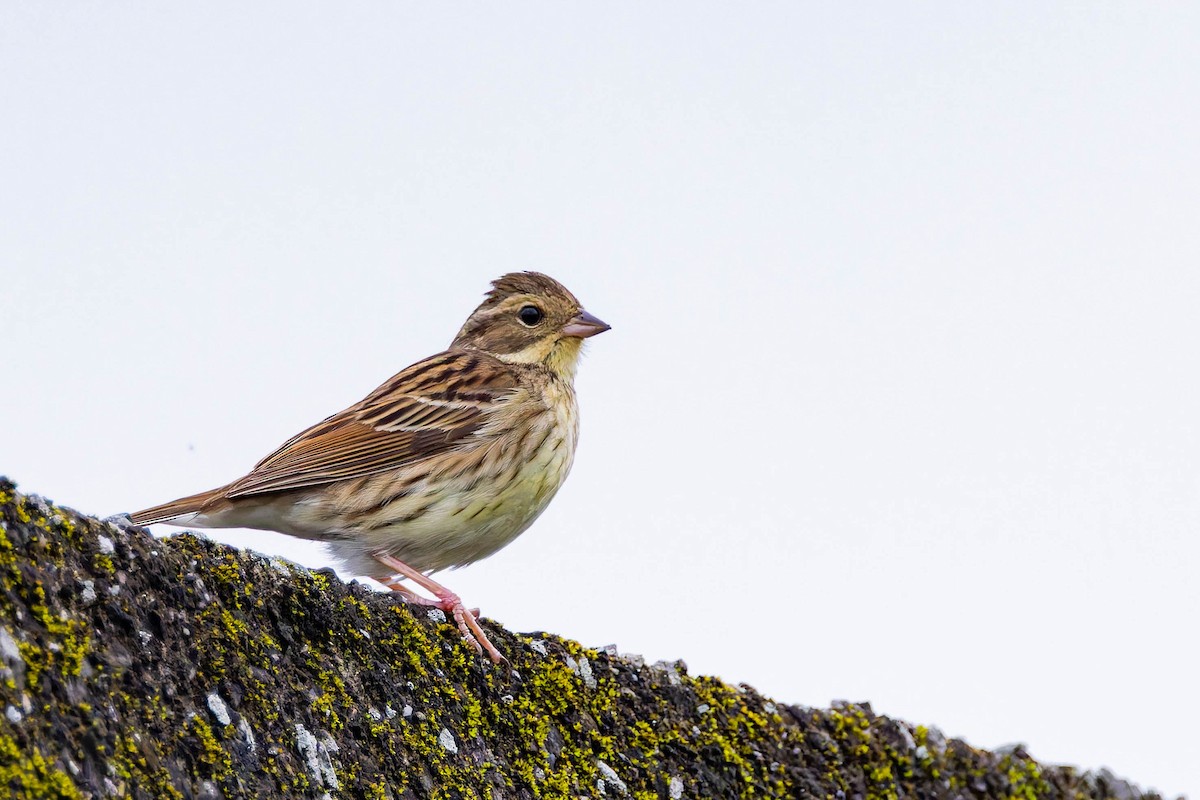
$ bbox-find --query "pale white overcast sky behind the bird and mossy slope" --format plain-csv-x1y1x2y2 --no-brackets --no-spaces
0,2,1200,795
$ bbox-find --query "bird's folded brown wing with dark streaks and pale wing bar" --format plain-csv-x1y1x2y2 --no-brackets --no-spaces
226,350,518,499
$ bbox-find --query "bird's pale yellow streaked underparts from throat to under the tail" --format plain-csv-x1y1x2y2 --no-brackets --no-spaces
189,338,582,579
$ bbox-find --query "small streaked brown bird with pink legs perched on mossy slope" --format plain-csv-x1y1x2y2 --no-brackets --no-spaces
131,272,608,662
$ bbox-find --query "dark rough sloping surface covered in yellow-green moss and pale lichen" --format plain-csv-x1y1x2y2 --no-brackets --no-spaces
0,479,1153,800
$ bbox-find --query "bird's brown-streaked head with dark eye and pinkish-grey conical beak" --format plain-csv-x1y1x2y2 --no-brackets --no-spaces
450,272,608,378
